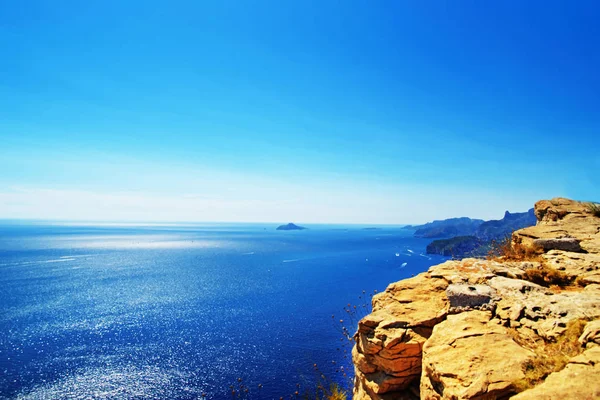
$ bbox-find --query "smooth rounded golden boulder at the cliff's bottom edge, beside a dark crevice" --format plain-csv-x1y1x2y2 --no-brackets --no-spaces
421,311,533,399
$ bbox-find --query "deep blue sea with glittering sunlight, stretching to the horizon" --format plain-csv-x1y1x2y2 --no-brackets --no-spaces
0,225,442,399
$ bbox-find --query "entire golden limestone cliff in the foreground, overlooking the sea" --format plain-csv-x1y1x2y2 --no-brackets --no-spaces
353,199,600,400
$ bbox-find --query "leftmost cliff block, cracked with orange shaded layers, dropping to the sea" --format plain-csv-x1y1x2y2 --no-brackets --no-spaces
352,274,448,399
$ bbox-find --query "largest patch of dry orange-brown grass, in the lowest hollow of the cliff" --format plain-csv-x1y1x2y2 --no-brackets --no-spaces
511,319,587,392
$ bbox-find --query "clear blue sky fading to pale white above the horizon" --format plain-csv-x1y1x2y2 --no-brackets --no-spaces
0,0,600,223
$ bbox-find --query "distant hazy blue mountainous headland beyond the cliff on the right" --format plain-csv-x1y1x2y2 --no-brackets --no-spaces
413,208,536,258
